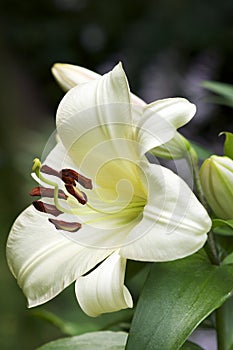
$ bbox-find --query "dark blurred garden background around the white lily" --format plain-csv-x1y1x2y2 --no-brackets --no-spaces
0,0,233,350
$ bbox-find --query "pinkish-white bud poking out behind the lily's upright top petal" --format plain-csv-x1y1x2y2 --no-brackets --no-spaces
52,63,146,106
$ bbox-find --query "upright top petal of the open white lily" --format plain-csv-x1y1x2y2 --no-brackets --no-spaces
57,65,141,183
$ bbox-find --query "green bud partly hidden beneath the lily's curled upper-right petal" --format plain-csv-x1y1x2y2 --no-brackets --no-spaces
150,132,191,159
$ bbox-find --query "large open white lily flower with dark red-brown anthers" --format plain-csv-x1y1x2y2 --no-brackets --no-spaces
7,64,211,316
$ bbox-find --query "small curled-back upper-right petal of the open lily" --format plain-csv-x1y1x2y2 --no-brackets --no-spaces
138,98,196,153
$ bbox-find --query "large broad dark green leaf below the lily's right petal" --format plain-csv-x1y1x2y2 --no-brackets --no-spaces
126,252,233,350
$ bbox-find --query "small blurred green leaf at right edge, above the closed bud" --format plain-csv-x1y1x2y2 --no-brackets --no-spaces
202,81,233,107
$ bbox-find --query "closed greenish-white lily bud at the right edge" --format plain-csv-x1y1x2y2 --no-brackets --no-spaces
200,156,233,220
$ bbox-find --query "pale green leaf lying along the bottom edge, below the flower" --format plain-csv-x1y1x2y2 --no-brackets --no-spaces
37,331,128,350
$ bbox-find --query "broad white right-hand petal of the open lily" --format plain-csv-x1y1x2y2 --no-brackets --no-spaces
119,163,211,261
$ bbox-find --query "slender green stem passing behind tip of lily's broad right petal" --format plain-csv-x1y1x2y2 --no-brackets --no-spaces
189,147,220,265
